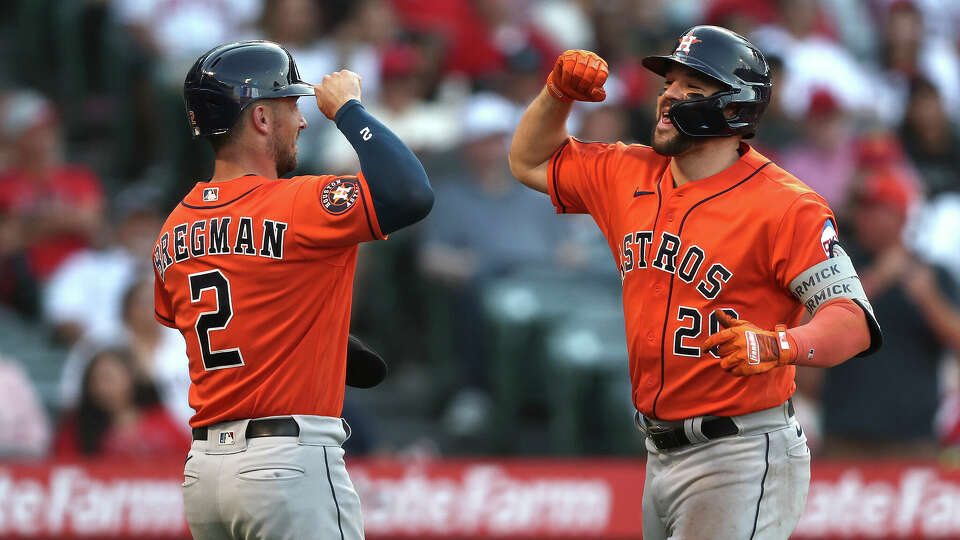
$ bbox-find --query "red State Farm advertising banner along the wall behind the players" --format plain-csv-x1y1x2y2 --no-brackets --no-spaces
0,459,960,540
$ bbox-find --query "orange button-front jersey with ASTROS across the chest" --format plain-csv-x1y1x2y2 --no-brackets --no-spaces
548,138,836,420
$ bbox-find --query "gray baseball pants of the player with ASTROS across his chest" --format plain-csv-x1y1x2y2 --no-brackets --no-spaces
637,403,810,540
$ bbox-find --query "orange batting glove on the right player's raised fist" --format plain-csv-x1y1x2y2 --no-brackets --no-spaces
547,50,610,101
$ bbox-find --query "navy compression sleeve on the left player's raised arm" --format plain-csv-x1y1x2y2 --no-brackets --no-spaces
333,99,433,234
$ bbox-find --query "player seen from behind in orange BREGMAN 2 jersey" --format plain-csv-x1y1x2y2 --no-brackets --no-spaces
153,41,433,540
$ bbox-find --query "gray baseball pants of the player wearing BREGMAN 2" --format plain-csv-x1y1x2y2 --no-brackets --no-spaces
183,415,363,540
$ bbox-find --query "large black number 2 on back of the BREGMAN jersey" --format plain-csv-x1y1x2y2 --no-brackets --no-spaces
190,270,243,371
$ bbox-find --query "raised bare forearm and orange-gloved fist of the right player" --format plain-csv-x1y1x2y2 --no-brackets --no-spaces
509,51,608,193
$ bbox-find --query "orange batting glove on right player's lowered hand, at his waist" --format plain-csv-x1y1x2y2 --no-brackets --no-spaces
701,309,797,377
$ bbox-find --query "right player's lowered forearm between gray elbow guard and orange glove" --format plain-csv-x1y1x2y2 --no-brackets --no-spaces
787,300,870,367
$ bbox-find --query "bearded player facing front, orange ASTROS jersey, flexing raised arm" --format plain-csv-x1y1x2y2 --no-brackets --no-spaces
510,26,881,540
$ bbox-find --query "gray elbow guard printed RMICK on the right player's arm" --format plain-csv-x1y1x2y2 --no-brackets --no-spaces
790,255,883,356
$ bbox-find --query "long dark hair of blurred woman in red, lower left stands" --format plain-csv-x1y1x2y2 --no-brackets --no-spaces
76,347,159,455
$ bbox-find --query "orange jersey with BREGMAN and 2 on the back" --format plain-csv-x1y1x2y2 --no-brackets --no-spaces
153,175,384,427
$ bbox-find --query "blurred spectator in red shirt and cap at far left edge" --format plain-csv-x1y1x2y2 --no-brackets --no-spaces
0,91,104,283
